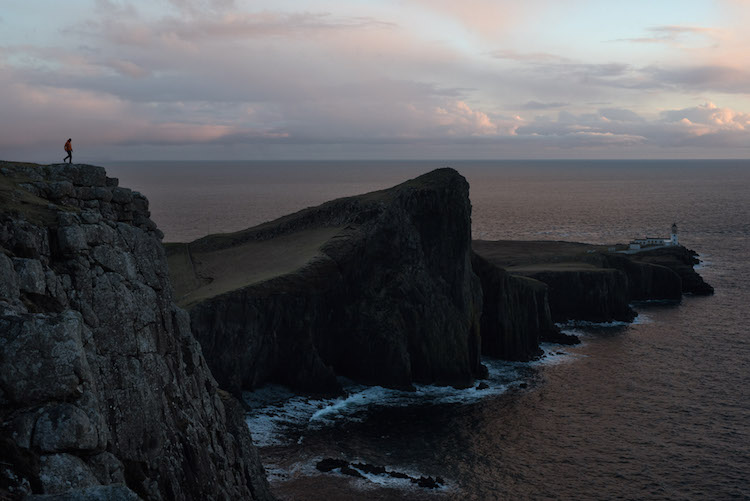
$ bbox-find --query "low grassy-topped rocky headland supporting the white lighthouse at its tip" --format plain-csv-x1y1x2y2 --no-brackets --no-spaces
472,240,713,322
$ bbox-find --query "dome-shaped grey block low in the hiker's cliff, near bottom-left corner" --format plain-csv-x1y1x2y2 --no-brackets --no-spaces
32,403,99,452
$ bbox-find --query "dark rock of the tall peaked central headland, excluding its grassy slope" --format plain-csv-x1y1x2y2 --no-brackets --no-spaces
178,169,484,392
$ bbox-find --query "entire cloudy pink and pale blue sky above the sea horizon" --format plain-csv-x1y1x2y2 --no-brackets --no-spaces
0,0,750,163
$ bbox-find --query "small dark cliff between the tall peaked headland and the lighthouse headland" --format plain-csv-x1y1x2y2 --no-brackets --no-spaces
471,253,560,361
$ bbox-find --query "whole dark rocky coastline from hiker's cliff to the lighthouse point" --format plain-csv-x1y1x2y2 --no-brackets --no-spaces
0,162,713,500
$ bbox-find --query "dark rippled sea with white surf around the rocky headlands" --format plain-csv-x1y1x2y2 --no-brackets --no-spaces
105,160,750,501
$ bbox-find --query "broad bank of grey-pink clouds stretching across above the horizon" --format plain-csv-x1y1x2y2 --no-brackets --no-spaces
0,0,750,157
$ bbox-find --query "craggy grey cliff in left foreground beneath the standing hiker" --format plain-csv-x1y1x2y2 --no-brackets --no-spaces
0,163,271,500
